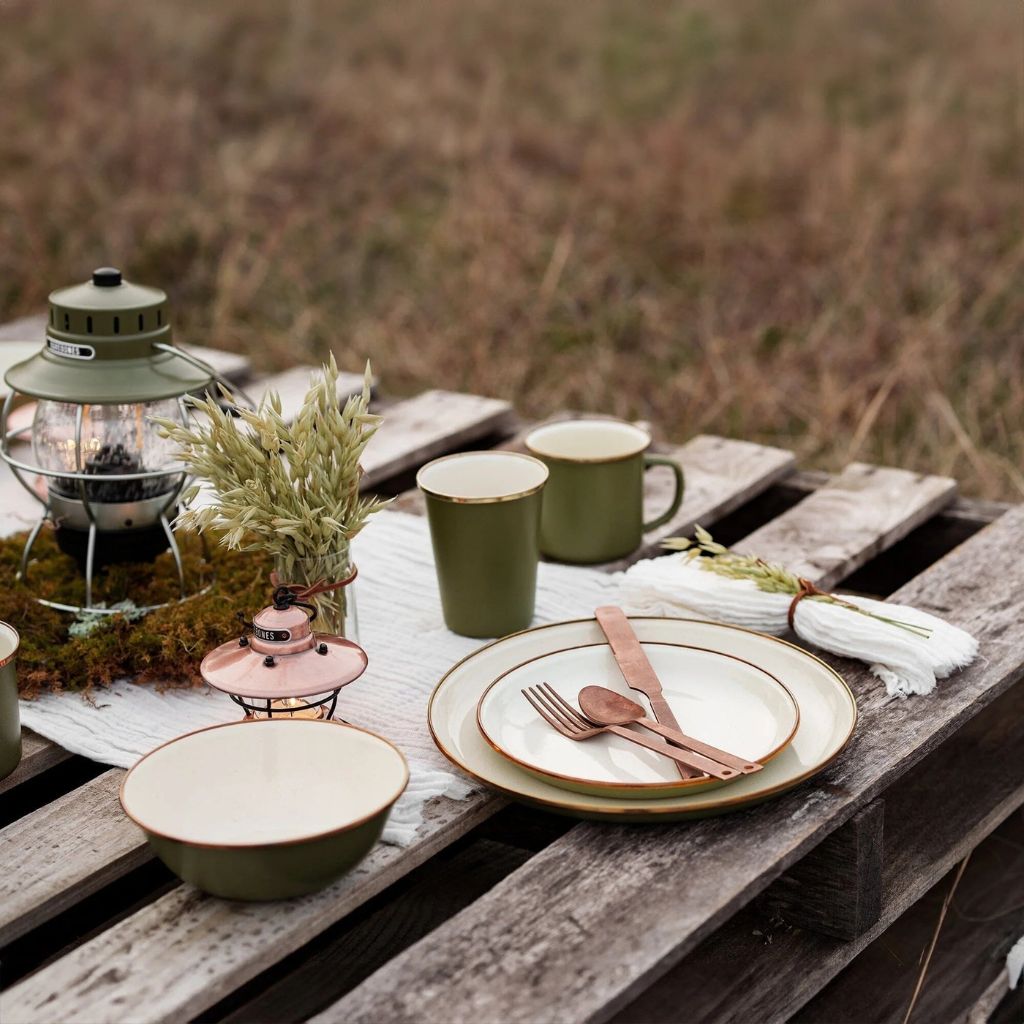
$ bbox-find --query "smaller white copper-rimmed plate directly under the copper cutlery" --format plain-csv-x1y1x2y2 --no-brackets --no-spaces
476,643,800,800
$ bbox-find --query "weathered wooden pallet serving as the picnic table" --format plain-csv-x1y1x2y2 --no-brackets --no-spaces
0,333,1024,1024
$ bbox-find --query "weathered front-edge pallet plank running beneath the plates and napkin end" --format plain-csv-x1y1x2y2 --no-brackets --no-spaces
316,509,1024,1024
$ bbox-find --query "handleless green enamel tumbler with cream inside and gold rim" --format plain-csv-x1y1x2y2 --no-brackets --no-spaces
416,452,548,637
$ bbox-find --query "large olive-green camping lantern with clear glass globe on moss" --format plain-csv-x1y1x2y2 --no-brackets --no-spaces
0,267,224,611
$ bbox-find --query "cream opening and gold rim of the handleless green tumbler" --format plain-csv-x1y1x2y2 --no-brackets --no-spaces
416,451,548,505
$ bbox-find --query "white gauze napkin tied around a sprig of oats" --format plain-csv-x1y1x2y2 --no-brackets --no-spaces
621,551,978,696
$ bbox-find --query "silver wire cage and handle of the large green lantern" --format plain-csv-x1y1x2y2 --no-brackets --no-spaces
0,360,255,615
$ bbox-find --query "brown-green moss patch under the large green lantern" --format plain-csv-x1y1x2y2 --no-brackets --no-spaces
0,532,271,696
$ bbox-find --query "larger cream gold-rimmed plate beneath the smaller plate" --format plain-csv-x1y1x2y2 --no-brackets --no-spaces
427,616,857,821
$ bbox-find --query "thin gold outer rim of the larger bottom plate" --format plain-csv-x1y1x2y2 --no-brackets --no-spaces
427,615,860,818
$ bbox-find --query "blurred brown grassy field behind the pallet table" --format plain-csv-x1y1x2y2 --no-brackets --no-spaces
0,0,1024,499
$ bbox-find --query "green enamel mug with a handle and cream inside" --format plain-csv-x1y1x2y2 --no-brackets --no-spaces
526,420,684,564
